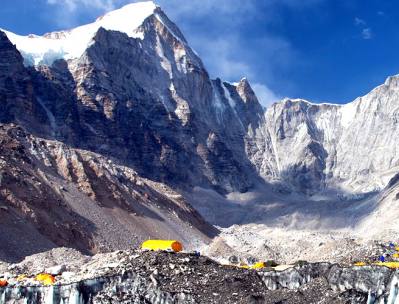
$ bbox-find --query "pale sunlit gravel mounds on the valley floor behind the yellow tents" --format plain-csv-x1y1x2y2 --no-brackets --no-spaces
202,224,399,264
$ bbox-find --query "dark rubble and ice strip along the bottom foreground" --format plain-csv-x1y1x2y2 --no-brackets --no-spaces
0,249,399,304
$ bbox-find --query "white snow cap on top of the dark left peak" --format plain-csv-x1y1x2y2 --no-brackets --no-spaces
3,1,157,65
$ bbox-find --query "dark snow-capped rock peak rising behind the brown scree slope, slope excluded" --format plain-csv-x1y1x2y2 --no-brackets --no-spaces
1,2,263,195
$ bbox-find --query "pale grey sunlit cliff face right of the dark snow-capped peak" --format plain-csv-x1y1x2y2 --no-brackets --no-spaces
250,76,399,196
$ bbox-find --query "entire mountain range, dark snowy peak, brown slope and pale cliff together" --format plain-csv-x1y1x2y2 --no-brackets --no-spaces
0,2,399,259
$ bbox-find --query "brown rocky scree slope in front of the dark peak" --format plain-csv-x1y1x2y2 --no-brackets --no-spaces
0,125,217,261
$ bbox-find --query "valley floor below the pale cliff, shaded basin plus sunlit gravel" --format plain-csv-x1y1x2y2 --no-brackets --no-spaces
189,187,399,263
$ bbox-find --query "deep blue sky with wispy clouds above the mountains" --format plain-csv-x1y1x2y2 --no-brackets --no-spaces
0,0,399,105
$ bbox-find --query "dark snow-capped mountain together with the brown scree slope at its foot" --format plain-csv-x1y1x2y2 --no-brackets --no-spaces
0,2,263,259
